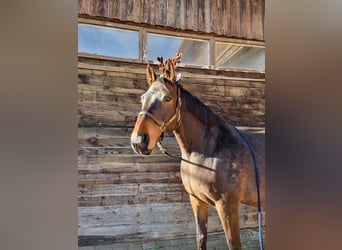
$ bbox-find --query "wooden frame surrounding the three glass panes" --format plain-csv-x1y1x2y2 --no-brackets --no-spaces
78,17,265,73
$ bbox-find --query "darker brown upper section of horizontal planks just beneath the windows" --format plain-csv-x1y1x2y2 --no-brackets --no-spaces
78,57,265,127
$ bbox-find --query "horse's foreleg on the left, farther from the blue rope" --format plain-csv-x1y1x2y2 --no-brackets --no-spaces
190,195,208,249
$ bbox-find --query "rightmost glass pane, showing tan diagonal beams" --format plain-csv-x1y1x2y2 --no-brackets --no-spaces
215,42,265,72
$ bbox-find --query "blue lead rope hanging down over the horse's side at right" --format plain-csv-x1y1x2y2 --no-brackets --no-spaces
234,127,264,250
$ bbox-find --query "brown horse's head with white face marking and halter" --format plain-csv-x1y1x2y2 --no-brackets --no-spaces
131,59,181,155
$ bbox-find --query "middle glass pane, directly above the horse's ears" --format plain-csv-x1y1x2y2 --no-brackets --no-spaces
147,34,209,66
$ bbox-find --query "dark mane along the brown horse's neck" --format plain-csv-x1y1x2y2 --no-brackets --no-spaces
181,87,227,127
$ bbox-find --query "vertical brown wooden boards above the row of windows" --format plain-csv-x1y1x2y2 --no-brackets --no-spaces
78,0,265,41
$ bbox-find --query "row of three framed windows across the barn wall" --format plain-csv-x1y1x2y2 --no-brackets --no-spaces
78,19,265,72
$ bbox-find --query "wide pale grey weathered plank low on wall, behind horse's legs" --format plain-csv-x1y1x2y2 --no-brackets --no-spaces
78,202,257,236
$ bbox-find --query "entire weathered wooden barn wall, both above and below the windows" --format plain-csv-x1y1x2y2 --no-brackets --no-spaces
78,0,265,248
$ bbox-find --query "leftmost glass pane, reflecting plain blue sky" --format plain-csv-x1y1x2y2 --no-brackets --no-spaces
78,24,139,59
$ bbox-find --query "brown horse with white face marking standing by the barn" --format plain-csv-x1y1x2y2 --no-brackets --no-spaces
130,58,265,249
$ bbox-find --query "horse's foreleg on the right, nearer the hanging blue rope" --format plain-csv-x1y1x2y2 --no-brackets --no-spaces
215,200,242,250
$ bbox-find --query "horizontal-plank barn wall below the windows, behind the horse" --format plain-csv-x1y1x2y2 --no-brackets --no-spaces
78,56,265,245
